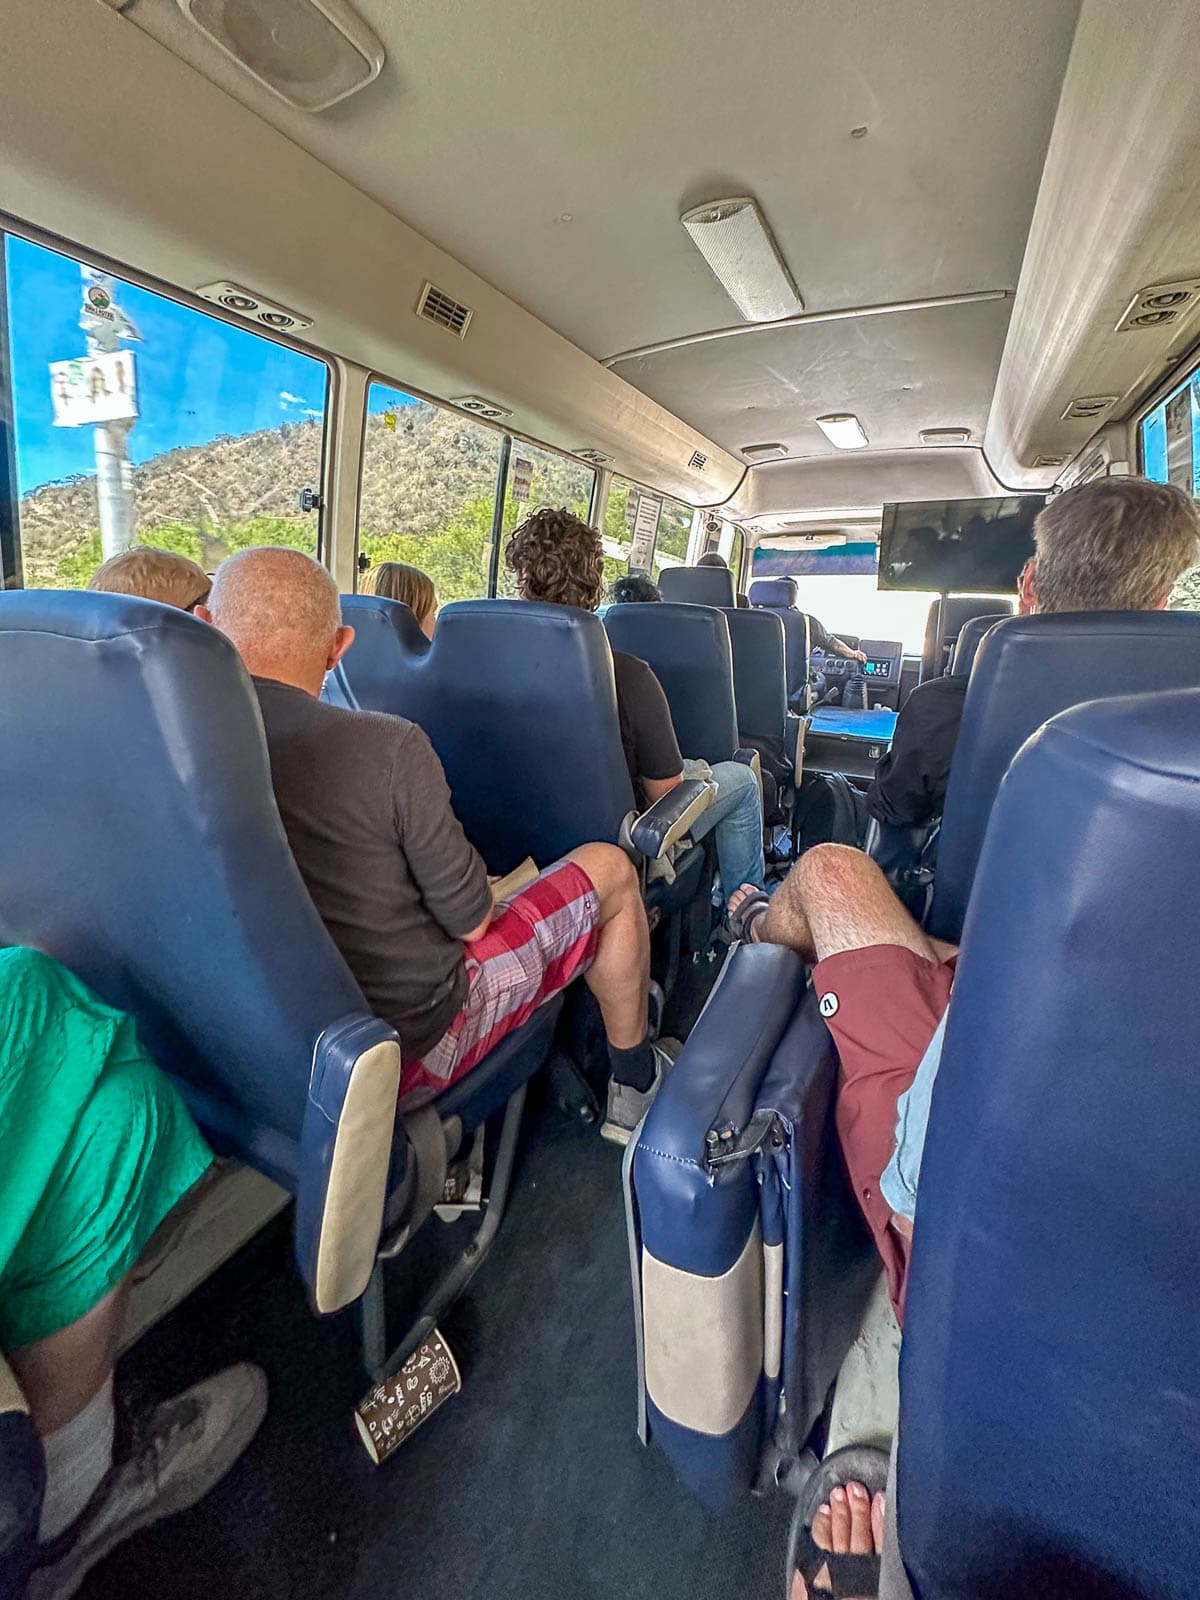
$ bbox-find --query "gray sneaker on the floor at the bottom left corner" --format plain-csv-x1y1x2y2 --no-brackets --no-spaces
27,1362,267,1600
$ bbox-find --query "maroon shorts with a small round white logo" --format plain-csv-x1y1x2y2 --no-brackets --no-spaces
813,944,957,1314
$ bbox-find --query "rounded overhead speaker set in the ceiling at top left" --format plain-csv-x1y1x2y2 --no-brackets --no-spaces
178,0,384,110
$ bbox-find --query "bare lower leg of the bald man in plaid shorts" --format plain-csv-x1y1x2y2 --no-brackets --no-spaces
566,845,650,1050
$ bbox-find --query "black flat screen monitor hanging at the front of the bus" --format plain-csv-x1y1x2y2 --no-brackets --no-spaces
878,494,1046,595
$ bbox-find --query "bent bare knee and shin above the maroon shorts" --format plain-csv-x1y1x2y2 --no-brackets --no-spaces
732,845,955,962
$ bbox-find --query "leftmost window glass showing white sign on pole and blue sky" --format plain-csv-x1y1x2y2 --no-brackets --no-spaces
5,235,328,589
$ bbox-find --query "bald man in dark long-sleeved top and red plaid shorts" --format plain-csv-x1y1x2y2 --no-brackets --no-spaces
197,549,669,1130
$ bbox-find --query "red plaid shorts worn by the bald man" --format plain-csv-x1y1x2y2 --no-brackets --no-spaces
400,861,600,1110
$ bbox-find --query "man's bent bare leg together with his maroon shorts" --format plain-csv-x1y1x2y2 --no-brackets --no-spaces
731,845,958,1315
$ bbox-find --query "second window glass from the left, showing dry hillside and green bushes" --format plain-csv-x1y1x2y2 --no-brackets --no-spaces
358,382,504,605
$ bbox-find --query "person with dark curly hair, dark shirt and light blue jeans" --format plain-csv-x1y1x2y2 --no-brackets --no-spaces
504,509,766,934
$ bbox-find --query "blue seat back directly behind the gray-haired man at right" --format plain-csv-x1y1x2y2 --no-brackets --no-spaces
928,611,1200,941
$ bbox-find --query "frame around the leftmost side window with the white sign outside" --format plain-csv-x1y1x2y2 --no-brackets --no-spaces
0,211,341,587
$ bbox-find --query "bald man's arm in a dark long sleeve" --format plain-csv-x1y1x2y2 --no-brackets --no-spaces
392,726,494,941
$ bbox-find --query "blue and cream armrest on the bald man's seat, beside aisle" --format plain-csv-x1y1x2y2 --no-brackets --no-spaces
296,1013,400,1312
